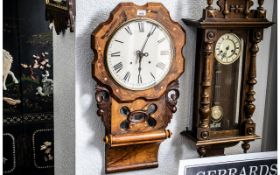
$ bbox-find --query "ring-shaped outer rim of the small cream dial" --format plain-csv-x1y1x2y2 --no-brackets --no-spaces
215,33,243,65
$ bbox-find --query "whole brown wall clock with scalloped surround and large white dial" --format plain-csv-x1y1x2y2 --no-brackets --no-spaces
92,3,185,173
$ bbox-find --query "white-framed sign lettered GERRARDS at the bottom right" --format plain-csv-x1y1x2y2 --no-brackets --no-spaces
178,152,277,175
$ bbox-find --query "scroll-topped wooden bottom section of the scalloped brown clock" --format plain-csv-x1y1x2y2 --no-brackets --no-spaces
105,130,171,173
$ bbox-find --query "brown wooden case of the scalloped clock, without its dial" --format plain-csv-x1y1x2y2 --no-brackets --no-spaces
92,3,186,173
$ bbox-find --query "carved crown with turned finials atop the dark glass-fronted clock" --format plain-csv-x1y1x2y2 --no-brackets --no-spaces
190,0,271,27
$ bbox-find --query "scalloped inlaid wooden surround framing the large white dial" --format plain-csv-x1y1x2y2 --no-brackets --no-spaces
92,3,186,102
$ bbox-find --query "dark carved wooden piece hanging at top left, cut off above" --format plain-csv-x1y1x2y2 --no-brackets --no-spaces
45,0,76,34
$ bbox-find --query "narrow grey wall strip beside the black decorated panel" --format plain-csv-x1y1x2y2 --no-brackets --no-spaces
53,29,76,175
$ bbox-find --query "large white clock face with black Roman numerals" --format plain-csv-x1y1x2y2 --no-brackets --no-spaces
106,19,174,90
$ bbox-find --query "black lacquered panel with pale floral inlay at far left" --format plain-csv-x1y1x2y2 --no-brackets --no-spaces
3,0,54,175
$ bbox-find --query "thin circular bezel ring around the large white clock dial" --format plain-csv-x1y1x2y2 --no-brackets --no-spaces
105,18,175,91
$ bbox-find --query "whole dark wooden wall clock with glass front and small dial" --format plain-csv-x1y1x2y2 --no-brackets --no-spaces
182,0,272,156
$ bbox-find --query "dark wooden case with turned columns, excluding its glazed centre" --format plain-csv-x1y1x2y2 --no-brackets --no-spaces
181,0,273,156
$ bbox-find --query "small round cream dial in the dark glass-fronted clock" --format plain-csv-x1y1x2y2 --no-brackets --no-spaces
215,33,242,64
